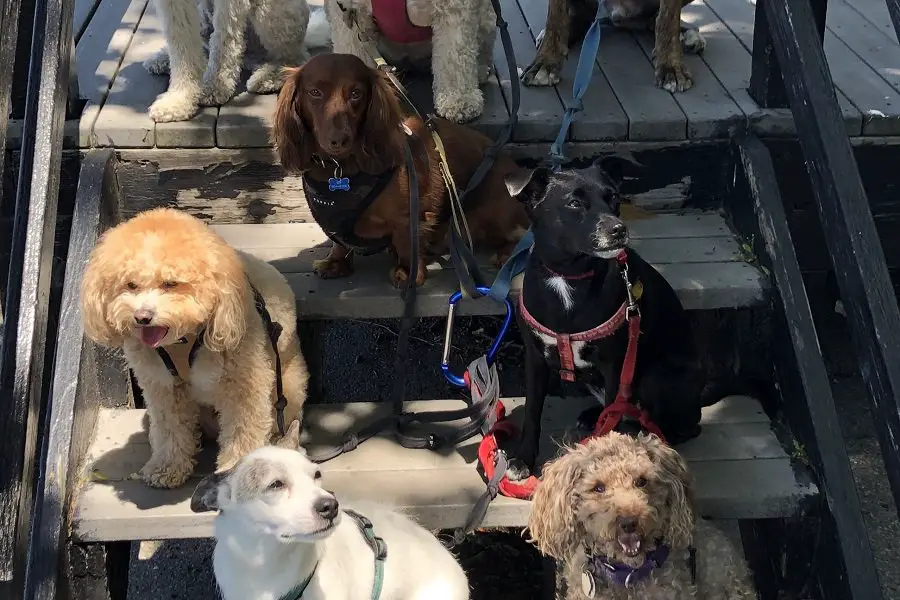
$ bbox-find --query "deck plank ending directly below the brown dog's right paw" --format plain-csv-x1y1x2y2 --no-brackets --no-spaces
597,28,687,141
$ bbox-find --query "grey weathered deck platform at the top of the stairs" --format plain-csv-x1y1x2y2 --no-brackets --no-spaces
10,0,900,148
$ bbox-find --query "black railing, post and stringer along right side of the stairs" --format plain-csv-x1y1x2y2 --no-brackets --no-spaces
741,0,900,600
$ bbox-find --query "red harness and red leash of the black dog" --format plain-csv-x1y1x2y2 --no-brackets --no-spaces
478,251,665,500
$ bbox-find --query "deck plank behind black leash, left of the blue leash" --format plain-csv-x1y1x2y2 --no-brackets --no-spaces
494,0,564,142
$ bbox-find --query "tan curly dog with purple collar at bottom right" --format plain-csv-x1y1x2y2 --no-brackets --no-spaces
528,432,756,600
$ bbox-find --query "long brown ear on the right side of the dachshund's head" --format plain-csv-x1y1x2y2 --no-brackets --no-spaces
357,69,405,174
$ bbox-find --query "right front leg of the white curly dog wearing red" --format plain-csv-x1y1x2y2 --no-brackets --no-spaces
431,0,484,123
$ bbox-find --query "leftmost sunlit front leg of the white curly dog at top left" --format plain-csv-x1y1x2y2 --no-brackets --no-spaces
148,0,206,123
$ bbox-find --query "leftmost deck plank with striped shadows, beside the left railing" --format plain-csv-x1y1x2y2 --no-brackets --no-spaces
75,0,147,147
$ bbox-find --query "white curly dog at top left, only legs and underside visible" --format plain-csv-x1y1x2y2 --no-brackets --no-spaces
144,0,328,122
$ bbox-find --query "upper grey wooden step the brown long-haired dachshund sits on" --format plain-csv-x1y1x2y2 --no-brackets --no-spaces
212,209,767,319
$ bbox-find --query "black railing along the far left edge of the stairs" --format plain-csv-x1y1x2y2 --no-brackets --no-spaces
0,0,74,600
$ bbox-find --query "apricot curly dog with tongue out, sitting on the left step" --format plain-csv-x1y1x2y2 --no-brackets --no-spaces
81,209,309,488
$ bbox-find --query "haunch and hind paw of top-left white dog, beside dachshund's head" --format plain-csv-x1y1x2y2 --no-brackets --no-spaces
247,0,309,94
